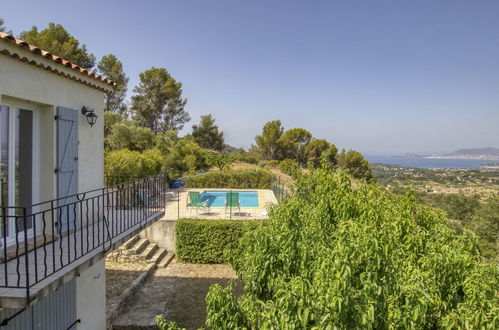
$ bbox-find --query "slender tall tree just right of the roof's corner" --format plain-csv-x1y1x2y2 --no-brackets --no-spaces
97,54,128,113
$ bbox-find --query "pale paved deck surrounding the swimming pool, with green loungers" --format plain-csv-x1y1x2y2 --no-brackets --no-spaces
165,188,277,220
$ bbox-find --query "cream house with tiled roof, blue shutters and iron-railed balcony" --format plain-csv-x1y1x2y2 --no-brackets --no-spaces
0,33,165,330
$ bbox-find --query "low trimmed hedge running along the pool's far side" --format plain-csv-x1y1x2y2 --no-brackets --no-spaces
183,169,274,189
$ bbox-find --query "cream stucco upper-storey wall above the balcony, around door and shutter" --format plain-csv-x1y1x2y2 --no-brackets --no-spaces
0,50,108,200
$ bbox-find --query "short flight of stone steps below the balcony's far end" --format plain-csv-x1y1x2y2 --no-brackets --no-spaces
107,235,173,268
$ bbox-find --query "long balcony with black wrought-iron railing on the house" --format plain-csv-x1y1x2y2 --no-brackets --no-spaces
0,176,167,308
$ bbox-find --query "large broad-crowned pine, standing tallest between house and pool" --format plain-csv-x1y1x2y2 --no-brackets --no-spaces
132,67,191,133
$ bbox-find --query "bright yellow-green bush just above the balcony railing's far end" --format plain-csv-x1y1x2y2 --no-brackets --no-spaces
104,149,163,178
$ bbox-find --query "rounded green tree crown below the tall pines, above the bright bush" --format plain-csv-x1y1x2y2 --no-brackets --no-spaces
105,120,156,151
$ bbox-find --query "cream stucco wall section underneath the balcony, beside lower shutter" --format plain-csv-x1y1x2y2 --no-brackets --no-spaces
76,259,106,330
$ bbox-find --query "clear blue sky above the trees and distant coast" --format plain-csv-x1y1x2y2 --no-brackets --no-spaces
0,0,499,154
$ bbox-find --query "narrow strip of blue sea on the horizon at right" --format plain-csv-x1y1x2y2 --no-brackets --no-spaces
364,155,499,168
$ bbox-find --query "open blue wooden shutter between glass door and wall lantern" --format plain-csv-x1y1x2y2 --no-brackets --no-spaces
57,107,78,232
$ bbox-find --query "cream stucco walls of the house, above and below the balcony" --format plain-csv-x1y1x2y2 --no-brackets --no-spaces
0,40,109,330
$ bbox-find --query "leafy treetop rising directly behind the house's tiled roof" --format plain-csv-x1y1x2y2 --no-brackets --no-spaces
19,23,95,69
